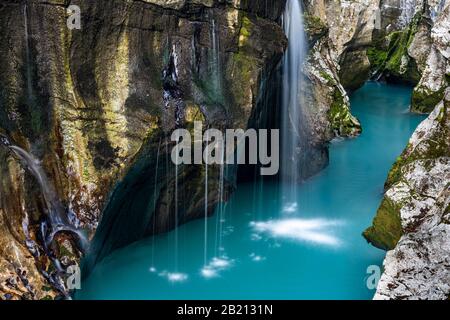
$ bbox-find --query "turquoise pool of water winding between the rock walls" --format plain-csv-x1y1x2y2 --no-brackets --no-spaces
76,83,424,299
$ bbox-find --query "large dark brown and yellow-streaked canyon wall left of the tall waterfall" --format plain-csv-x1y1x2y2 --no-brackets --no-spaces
0,0,286,299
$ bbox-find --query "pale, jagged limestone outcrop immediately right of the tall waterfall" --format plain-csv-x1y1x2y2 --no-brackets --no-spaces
304,1,378,141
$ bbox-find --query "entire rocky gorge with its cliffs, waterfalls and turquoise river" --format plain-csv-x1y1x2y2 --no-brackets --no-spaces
0,0,450,299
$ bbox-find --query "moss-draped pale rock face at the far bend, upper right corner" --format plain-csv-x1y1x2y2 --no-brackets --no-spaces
367,0,450,113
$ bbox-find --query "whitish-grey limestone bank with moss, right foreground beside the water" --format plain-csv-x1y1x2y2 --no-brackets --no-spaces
365,89,450,299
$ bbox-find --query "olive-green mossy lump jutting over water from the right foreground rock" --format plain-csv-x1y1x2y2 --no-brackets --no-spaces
363,199,403,250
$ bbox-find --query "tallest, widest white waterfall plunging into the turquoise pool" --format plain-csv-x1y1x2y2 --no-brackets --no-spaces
280,0,306,213
